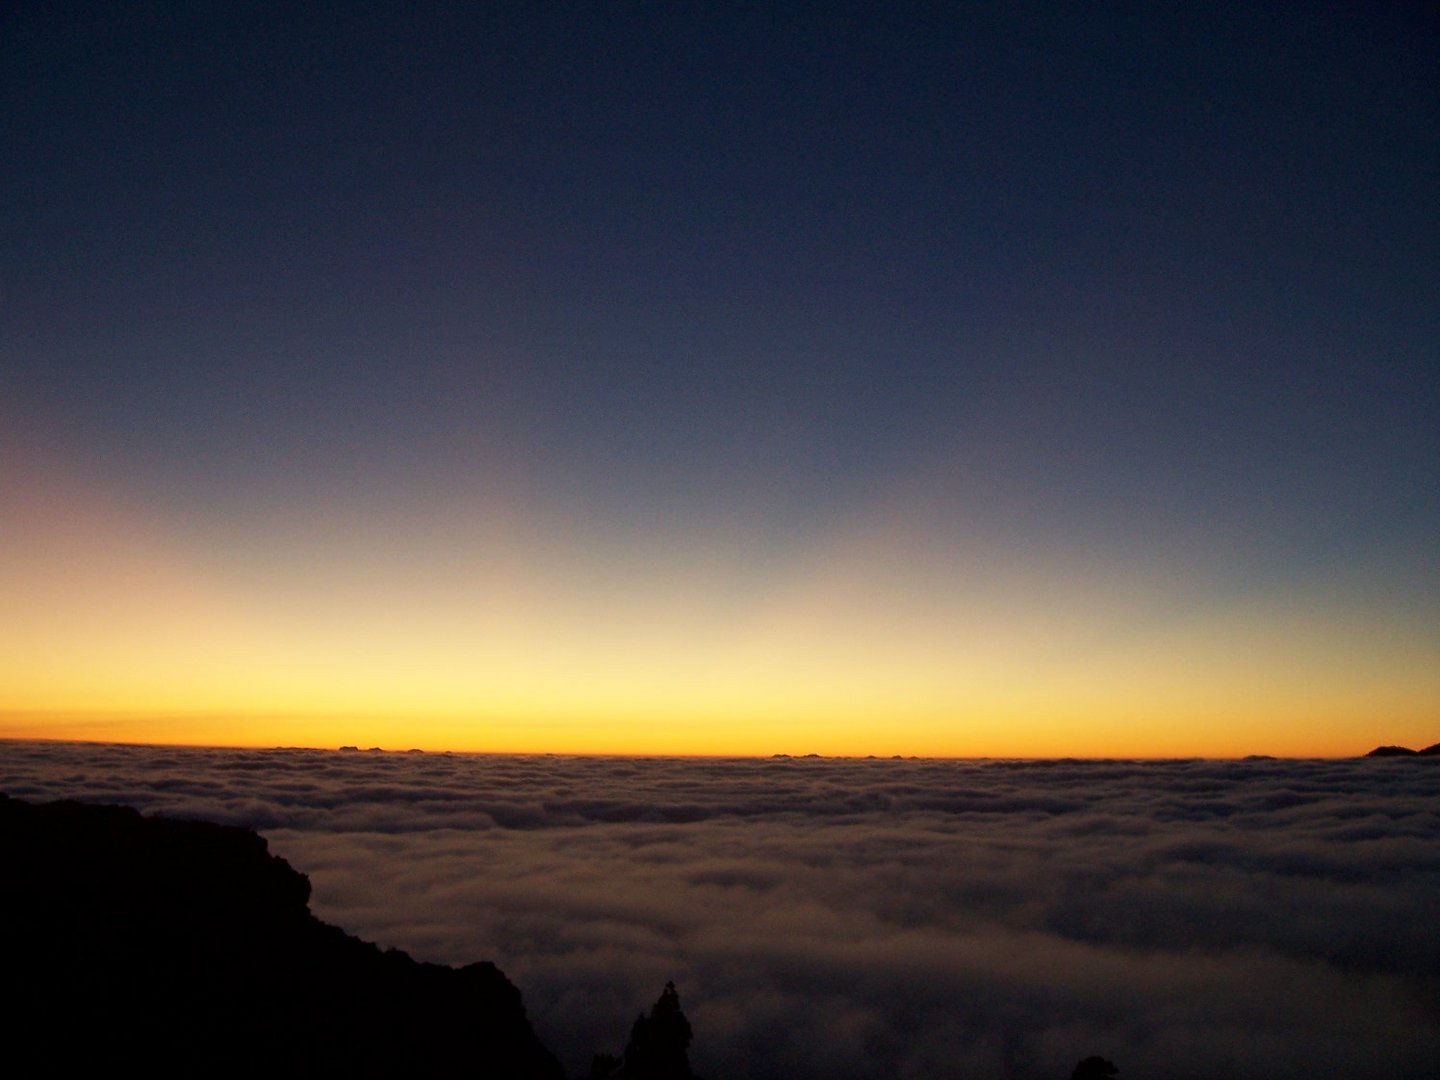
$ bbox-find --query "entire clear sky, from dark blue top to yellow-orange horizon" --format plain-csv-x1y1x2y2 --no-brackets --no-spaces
0,3,1440,756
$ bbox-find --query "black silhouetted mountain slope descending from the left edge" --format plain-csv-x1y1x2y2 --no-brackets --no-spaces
0,795,563,1080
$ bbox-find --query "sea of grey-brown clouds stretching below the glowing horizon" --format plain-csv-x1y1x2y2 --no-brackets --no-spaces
0,743,1440,1080
